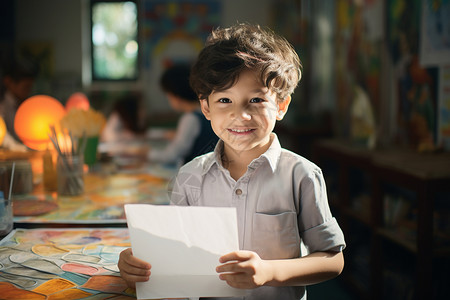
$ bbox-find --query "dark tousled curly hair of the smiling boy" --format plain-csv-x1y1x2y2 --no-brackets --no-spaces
190,24,302,99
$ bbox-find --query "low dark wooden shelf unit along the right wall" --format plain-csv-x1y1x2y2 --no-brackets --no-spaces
313,139,450,299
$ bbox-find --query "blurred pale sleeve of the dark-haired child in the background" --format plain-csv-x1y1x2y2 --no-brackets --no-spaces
148,113,201,163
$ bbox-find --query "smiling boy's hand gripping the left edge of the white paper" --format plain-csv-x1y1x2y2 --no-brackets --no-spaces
117,248,152,288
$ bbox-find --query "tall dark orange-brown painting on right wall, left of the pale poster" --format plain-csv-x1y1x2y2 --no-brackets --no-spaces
387,0,438,150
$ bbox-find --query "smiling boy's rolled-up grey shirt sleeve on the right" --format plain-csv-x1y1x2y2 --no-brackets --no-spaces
298,169,345,252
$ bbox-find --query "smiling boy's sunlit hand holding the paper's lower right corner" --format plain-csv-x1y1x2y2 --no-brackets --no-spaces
216,250,273,289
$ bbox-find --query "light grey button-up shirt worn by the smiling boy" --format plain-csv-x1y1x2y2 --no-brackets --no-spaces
171,134,345,300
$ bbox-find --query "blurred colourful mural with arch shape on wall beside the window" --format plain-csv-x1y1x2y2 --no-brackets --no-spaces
141,0,222,112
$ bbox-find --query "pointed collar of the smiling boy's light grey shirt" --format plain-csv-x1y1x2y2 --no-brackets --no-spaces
203,132,281,174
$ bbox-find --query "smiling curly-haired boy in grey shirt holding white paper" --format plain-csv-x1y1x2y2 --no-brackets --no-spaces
119,25,345,300
